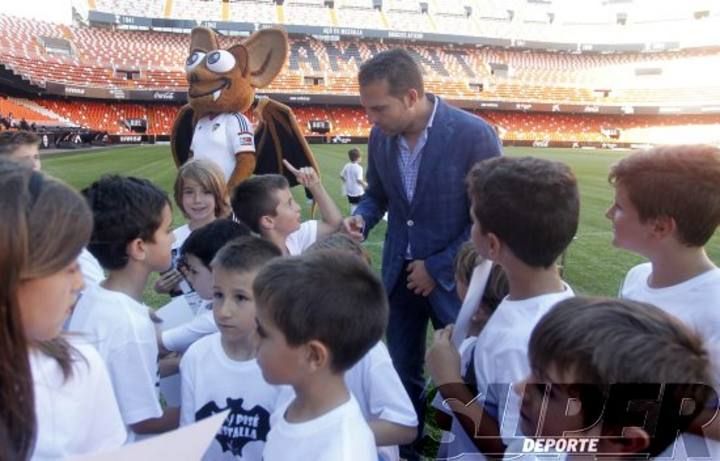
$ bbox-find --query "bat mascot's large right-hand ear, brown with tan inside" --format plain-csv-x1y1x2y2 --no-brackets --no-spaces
242,29,288,88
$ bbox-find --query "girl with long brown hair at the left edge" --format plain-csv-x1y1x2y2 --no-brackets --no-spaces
0,158,127,460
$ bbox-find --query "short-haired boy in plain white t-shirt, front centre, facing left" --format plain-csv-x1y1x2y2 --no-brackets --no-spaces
253,251,388,461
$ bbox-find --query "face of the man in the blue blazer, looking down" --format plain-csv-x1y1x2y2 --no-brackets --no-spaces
360,80,416,136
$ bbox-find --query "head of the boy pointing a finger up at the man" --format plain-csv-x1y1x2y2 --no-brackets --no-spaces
232,174,300,236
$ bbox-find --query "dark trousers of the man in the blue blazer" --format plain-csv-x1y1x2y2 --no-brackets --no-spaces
387,261,452,460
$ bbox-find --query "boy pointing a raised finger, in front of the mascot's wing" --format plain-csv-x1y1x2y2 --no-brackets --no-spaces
232,162,342,256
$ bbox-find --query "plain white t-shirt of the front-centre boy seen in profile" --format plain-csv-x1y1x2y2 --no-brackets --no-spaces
263,393,378,461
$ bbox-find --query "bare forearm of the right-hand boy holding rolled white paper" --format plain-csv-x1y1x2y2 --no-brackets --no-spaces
425,325,506,455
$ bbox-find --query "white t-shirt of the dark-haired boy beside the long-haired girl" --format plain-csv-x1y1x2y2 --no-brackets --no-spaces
68,285,162,425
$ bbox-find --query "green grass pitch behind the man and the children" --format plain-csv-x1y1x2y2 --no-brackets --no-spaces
43,145,720,307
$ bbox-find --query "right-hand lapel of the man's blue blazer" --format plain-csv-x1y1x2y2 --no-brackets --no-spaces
410,96,453,211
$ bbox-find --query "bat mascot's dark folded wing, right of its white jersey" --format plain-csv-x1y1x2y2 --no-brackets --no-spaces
255,98,320,187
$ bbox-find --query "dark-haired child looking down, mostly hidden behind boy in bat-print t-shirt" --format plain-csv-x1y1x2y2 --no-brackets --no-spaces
160,219,250,354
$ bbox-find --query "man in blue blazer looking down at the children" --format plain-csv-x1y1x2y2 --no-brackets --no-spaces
343,49,501,454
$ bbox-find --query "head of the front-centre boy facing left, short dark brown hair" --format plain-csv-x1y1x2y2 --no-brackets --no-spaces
253,251,388,385
